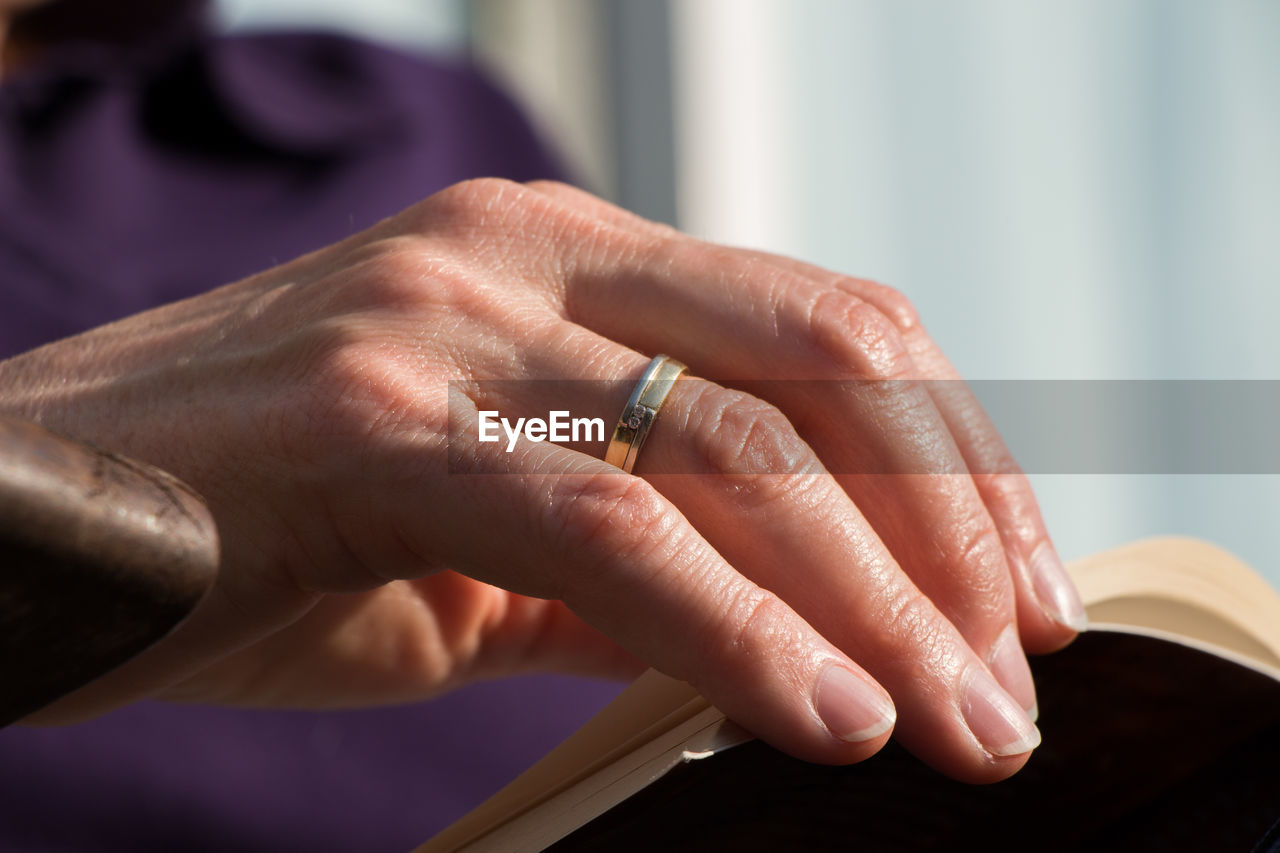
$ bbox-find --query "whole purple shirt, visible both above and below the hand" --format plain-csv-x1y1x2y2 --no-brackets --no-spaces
0,19,618,852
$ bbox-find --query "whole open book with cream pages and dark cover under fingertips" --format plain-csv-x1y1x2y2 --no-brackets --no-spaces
419,538,1280,853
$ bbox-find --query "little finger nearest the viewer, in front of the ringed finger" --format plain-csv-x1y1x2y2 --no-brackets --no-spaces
435,406,893,763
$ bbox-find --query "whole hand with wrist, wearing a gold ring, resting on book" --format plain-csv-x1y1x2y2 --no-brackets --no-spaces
0,181,1083,781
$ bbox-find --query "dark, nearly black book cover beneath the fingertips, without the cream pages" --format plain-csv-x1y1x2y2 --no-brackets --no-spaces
550,631,1280,853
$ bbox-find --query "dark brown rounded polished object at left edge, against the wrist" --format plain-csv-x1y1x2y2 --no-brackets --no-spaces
0,418,218,725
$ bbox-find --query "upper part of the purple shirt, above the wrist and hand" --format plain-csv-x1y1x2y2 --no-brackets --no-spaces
0,23,561,356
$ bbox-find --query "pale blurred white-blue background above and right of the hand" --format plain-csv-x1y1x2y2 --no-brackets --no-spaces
219,0,1280,585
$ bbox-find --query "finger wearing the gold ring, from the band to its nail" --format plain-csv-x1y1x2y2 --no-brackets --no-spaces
454,330,1038,781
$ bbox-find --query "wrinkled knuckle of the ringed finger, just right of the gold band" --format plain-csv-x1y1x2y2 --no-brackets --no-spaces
692,386,820,483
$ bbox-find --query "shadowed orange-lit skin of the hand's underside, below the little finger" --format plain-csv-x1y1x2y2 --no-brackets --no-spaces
160,571,646,708
